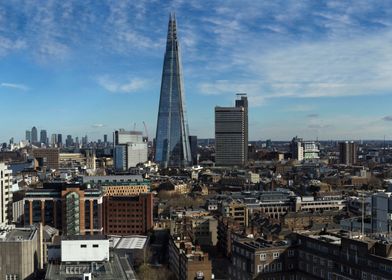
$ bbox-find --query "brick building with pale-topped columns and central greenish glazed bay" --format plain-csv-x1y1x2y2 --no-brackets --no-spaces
24,185,103,235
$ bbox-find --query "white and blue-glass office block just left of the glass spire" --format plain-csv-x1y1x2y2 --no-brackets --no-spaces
113,129,148,170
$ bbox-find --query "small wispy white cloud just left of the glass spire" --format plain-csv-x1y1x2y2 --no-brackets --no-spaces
97,76,148,93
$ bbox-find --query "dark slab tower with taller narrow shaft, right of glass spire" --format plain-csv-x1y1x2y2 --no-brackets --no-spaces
215,94,248,166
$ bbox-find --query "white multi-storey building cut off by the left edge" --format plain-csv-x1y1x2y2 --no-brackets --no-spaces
0,162,12,225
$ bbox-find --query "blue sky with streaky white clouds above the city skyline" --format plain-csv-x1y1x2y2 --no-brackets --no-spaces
0,0,392,142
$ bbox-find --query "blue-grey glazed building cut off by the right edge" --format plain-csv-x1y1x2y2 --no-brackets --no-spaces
371,192,392,234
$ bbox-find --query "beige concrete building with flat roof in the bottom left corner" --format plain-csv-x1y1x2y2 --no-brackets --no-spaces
0,226,42,280
